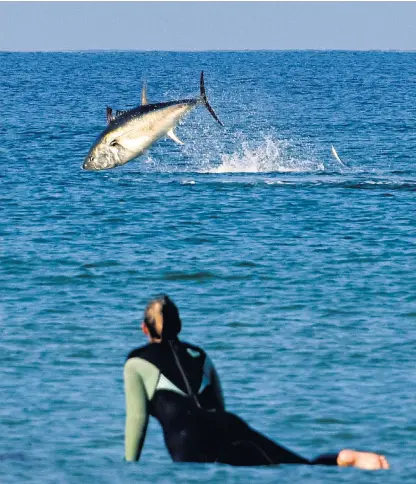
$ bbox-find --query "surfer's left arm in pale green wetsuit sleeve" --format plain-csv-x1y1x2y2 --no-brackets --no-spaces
124,358,153,461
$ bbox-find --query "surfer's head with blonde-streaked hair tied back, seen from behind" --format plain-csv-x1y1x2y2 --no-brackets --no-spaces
142,295,182,343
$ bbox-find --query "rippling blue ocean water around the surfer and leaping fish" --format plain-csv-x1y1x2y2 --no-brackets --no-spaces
0,52,416,484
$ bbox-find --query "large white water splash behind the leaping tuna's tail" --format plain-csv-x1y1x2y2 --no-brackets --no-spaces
200,137,325,173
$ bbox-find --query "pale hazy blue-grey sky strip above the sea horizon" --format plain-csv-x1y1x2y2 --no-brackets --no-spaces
0,2,416,51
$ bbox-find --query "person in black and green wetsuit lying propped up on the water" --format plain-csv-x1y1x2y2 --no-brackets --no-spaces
124,296,389,469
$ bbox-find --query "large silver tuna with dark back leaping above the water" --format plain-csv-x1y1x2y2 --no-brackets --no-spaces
82,71,224,170
